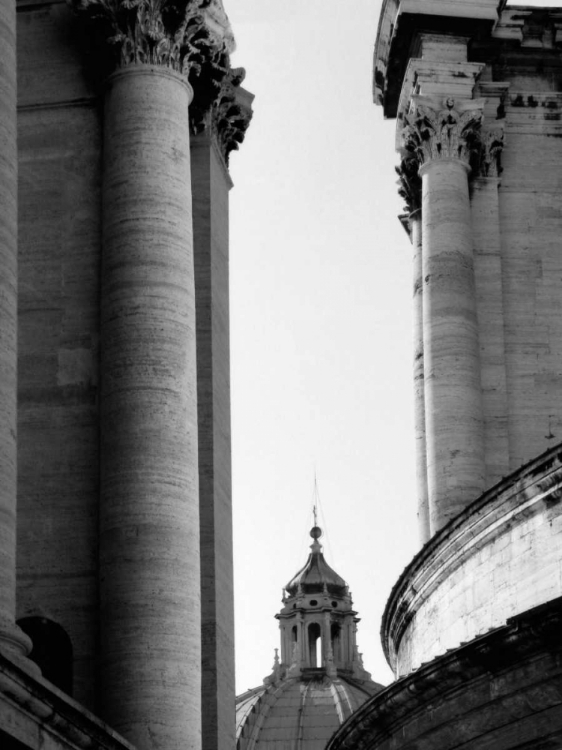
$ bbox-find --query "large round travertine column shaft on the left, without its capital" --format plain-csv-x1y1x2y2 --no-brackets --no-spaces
100,64,201,750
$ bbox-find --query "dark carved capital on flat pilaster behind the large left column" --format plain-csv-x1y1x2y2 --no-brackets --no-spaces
190,68,254,166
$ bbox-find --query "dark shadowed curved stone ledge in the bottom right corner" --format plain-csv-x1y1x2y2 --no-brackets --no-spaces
327,598,562,750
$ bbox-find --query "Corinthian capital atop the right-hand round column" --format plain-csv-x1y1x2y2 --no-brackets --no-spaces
402,95,484,170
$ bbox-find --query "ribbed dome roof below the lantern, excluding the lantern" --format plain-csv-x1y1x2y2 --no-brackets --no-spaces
232,672,382,750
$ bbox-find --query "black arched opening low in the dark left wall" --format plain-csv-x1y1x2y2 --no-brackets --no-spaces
17,617,72,695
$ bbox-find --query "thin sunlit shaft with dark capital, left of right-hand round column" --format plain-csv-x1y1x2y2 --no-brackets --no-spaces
397,157,431,546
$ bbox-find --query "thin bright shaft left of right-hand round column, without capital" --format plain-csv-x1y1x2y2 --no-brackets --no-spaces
410,211,431,545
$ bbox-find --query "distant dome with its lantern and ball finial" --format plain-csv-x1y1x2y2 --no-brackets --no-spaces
236,524,383,750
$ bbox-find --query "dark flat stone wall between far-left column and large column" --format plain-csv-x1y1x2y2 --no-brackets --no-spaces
17,3,102,710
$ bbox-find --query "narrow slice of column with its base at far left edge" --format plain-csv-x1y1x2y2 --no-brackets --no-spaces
0,0,32,669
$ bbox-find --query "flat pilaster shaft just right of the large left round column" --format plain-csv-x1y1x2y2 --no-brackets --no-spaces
191,131,235,750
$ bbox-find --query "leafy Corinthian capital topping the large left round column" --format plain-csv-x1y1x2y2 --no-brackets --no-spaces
72,0,234,78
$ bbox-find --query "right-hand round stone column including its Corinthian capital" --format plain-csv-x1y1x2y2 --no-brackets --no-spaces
406,96,485,534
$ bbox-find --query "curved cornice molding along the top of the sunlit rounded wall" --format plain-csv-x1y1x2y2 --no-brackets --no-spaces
381,444,562,673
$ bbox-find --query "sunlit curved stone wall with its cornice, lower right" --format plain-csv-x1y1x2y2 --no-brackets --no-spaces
381,445,562,677
